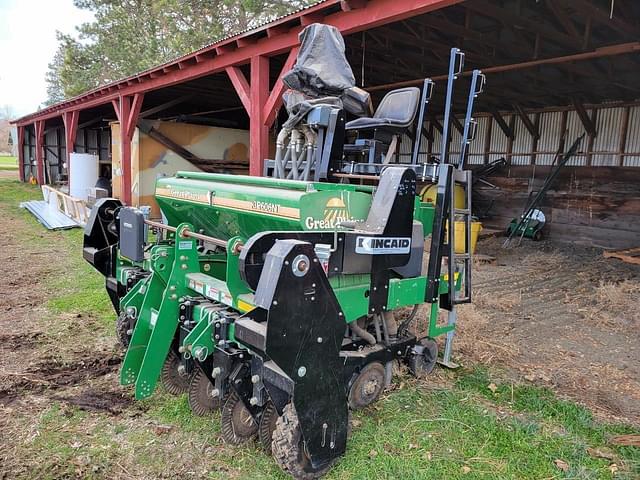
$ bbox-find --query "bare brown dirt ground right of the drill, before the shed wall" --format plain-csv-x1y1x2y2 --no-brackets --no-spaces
456,238,640,424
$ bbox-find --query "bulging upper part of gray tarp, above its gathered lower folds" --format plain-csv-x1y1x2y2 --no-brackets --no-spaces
282,23,356,98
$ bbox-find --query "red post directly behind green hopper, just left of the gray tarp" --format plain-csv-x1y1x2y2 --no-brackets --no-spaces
249,55,269,177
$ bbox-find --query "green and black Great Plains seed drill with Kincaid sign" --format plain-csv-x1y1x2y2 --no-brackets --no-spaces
84,25,483,479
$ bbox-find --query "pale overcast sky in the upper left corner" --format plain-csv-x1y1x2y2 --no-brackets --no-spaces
0,0,92,116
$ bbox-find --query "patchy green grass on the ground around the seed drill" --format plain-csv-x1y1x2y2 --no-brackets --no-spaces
0,179,640,480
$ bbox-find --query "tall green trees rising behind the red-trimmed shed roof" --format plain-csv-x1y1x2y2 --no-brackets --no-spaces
46,0,313,104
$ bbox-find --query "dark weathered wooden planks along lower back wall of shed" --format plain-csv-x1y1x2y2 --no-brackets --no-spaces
474,166,640,248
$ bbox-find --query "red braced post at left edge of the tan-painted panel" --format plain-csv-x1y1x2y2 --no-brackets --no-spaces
113,93,144,205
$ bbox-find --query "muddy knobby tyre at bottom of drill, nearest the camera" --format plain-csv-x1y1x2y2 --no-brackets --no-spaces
271,403,333,480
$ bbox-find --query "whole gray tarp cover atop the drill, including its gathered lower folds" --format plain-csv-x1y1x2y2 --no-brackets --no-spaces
282,23,356,128
